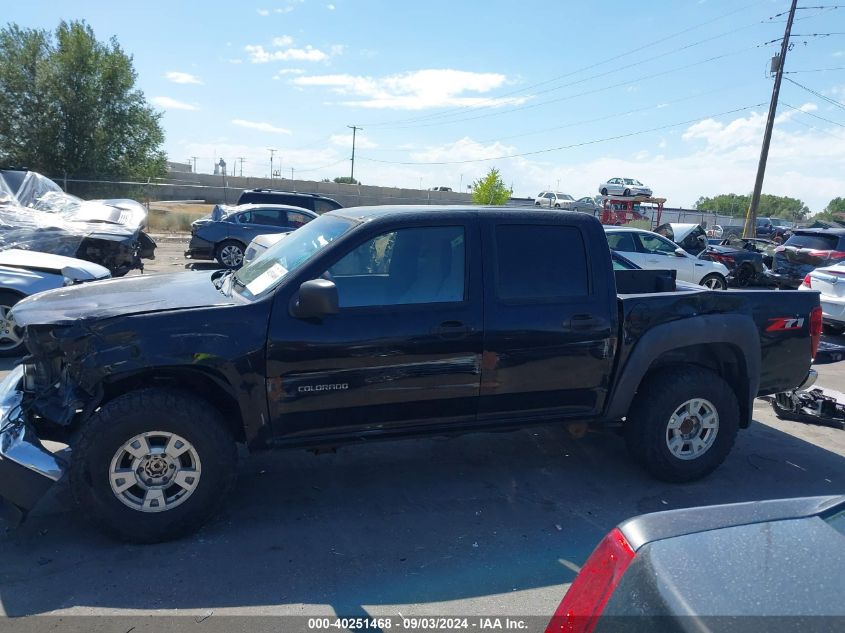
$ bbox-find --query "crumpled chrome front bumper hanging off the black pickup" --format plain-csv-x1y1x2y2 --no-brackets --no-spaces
0,366,67,523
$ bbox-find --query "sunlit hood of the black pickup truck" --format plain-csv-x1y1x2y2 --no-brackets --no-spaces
12,272,240,327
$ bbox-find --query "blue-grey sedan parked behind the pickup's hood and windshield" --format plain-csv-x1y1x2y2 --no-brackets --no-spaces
185,204,317,268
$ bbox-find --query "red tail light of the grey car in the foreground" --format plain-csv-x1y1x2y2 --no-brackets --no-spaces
546,528,636,633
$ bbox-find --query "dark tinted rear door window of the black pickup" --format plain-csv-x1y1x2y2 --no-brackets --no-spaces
496,224,590,301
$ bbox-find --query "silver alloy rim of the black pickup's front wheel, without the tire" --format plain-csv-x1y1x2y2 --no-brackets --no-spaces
109,431,202,512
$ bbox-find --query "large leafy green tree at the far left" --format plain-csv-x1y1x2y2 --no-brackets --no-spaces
0,21,166,178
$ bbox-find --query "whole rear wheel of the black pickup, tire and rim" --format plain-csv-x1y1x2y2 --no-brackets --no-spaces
624,367,739,483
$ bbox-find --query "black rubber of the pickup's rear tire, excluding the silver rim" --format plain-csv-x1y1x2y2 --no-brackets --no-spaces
624,366,739,483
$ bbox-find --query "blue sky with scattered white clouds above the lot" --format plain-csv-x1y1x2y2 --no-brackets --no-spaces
4,0,845,211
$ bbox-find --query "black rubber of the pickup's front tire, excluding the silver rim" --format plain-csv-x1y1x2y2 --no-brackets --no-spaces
69,388,237,543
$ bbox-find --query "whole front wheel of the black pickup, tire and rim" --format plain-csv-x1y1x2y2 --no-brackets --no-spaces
70,388,237,543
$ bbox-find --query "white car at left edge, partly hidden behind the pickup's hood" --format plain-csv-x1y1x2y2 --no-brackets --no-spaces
0,248,111,356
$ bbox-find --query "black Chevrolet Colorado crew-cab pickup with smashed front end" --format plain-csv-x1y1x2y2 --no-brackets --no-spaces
0,207,821,542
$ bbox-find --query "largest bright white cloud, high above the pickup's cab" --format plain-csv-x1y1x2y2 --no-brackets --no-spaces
293,69,528,110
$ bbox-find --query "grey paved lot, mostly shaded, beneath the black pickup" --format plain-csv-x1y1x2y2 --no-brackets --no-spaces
0,240,845,631
